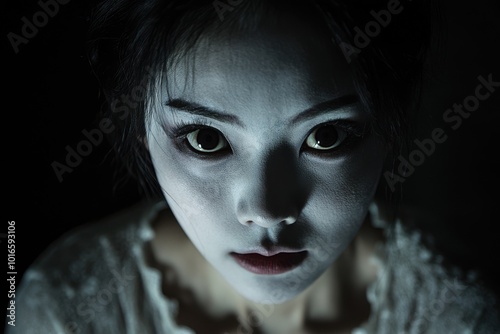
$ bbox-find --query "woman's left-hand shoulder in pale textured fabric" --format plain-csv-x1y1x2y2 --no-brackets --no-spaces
8,203,168,333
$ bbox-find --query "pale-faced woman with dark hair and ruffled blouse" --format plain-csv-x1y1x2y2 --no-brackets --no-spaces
9,0,498,333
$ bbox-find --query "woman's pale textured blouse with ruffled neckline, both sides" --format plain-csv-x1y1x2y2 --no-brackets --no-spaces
6,203,500,334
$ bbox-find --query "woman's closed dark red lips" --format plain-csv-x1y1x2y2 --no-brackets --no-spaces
231,251,307,275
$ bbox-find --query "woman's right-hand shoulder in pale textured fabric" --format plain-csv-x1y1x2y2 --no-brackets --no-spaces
368,201,500,333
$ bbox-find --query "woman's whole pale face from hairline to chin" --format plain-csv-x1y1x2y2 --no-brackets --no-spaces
147,14,386,303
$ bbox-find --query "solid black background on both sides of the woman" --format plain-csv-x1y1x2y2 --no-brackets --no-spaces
1,0,500,326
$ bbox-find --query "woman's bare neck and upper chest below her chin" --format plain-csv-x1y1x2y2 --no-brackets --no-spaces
151,207,384,334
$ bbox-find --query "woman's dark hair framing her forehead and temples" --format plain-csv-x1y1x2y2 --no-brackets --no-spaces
89,0,438,195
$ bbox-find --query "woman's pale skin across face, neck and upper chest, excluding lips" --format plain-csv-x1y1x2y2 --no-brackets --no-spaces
146,10,387,333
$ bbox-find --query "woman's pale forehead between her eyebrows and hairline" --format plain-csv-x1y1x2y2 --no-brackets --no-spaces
162,12,355,123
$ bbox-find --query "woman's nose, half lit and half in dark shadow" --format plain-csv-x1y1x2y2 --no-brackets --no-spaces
236,144,308,228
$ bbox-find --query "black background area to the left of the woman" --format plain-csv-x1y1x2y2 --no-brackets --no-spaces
2,0,144,316
